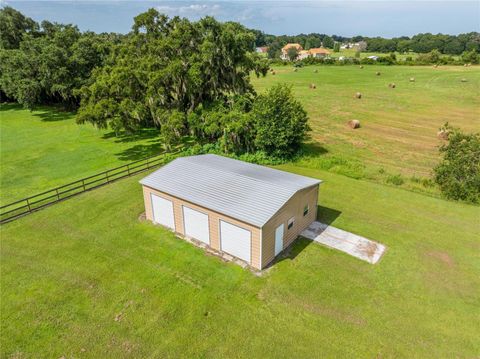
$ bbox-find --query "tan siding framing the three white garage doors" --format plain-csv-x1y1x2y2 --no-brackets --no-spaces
143,186,261,269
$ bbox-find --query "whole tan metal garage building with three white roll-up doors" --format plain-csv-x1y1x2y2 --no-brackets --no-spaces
140,154,321,269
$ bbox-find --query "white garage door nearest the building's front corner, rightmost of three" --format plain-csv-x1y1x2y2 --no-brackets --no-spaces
220,221,252,263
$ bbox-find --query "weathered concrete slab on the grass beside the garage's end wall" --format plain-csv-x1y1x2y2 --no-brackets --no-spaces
301,221,386,264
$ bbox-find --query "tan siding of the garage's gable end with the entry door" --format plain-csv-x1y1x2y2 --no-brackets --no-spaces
262,185,318,267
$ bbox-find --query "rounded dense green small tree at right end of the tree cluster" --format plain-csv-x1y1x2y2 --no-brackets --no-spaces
253,84,309,157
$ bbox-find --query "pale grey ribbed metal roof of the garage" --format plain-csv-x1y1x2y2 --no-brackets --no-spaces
140,154,321,227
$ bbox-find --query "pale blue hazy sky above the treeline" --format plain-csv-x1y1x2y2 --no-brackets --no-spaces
0,0,480,37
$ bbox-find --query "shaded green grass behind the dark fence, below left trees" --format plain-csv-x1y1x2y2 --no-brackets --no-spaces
0,104,161,204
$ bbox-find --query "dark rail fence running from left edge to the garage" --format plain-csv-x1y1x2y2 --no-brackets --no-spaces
0,155,165,224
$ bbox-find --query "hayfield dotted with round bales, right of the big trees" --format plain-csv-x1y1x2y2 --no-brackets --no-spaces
253,65,480,179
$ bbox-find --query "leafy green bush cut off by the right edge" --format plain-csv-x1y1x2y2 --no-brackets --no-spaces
434,123,480,203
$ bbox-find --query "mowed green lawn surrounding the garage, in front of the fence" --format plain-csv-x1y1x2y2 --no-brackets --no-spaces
0,165,480,358
